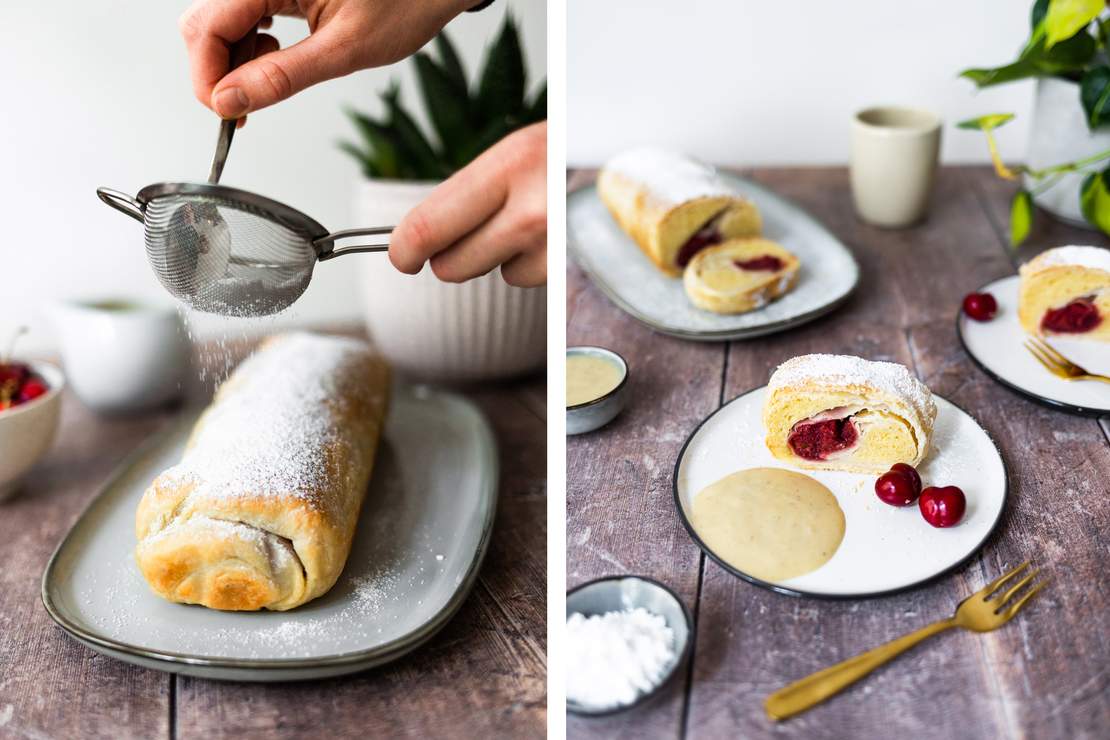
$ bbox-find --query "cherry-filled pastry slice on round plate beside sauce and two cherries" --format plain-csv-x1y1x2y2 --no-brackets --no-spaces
763,355,937,473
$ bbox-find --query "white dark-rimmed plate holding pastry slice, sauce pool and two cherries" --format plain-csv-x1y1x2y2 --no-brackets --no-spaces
674,386,1007,598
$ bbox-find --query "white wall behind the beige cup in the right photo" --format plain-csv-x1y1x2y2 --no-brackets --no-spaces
567,0,1032,165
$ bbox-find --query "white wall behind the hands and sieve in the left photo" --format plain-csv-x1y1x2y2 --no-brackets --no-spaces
0,0,547,353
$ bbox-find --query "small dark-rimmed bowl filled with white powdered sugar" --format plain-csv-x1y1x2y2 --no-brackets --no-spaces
566,576,694,716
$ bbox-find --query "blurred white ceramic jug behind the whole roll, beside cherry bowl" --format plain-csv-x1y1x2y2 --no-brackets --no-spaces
51,301,192,413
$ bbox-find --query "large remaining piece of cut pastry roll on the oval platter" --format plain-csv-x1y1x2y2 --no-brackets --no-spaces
597,149,761,276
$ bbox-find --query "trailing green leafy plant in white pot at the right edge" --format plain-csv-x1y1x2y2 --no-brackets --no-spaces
958,0,1110,244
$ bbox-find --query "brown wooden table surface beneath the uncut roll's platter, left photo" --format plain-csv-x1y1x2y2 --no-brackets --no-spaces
0,332,547,740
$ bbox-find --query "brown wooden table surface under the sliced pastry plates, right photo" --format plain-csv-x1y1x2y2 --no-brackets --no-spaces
567,168,1110,740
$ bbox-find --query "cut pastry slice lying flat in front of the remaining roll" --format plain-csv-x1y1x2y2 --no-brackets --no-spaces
683,239,800,314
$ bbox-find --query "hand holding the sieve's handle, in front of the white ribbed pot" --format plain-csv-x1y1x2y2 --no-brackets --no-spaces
390,122,547,287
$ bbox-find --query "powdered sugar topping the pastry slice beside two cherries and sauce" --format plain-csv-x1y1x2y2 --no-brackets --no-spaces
767,354,937,419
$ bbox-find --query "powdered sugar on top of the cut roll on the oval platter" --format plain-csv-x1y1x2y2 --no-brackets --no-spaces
605,146,737,205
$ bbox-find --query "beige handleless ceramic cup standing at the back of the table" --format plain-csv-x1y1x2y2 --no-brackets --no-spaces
851,105,940,229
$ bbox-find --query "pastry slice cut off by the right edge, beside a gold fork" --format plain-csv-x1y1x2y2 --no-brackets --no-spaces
1018,246,1110,342
